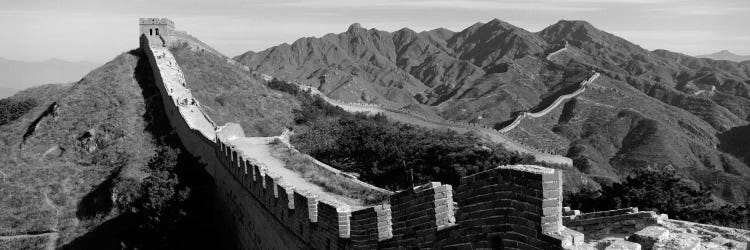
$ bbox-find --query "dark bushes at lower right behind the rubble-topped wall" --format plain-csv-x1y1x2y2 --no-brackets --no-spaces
563,169,750,229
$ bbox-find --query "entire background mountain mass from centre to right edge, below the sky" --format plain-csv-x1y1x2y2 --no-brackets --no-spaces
235,19,750,204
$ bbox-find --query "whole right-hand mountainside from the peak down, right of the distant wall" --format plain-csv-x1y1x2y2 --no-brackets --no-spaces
528,21,750,204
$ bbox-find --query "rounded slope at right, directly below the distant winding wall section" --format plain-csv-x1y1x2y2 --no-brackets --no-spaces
548,77,750,204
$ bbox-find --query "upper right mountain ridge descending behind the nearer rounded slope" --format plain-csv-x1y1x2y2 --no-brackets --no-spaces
539,21,750,131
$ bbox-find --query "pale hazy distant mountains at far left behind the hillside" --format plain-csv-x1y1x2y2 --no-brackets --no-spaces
0,58,101,98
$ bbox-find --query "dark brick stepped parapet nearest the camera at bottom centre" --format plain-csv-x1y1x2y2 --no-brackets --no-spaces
378,165,572,249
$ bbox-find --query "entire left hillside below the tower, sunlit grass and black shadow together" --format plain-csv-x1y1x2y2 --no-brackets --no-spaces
0,50,215,249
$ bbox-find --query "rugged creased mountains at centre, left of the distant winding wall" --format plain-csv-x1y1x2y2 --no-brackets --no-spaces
235,19,583,126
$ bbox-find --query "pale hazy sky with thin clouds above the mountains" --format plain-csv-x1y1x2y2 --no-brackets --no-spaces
0,0,750,62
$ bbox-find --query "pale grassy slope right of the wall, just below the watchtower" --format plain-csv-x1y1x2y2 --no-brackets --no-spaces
172,43,299,136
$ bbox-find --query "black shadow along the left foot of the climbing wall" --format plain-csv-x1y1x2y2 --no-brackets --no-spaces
62,49,220,249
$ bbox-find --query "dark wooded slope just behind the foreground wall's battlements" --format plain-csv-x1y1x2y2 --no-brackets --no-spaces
268,80,533,190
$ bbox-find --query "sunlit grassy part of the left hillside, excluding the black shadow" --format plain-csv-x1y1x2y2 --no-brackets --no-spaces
0,54,153,240
